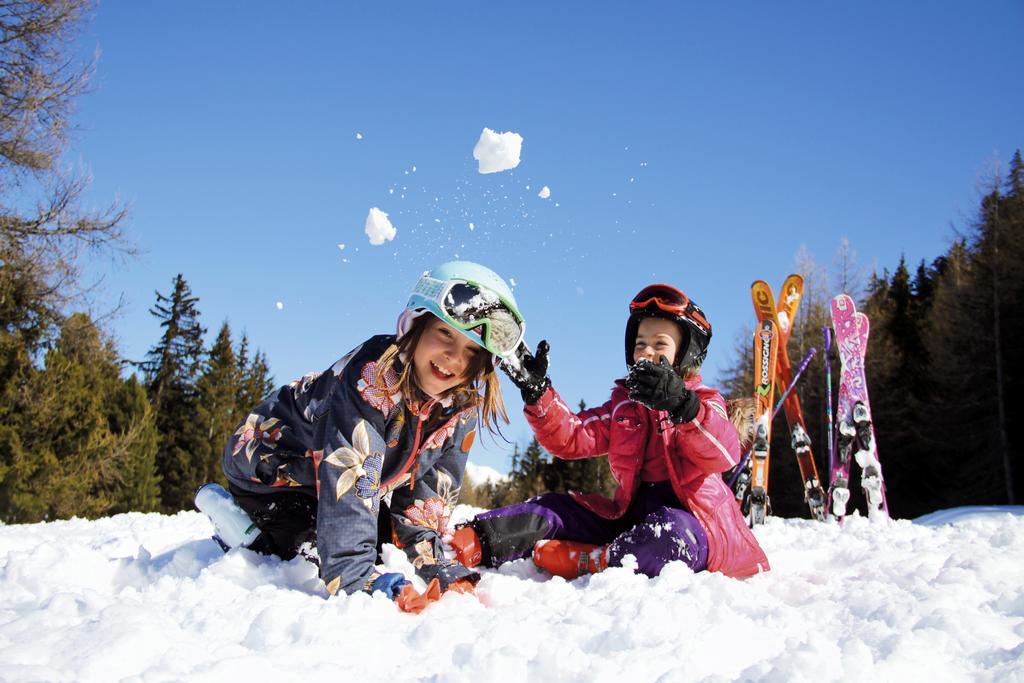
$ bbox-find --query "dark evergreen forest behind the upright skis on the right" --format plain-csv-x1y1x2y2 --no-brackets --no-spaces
722,151,1024,517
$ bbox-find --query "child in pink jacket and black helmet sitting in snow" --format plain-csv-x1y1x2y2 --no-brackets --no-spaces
453,285,768,578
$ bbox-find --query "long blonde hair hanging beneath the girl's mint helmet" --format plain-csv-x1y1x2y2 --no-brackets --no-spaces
377,313,509,434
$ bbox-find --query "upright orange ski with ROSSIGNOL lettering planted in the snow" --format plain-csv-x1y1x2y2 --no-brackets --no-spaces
742,321,779,526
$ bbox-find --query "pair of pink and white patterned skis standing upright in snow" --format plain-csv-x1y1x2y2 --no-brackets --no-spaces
828,294,889,520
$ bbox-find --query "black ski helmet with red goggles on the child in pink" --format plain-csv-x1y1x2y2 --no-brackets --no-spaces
626,285,711,371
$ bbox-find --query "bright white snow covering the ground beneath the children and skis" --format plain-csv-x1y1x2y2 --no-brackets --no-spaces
0,508,1024,683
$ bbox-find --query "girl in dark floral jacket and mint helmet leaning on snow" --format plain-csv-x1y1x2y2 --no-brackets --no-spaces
207,262,523,608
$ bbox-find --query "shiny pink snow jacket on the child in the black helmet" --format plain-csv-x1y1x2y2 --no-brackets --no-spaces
524,376,769,577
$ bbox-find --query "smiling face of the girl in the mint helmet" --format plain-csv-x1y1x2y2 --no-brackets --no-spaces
413,315,484,397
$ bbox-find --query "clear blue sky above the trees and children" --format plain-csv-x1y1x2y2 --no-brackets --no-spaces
69,0,1024,470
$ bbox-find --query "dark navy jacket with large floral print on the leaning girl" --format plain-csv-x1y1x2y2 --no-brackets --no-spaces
221,335,479,595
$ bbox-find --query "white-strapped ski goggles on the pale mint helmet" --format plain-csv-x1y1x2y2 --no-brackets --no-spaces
413,275,526,357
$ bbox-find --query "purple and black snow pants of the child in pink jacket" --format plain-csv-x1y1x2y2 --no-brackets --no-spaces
470,481,708,577
